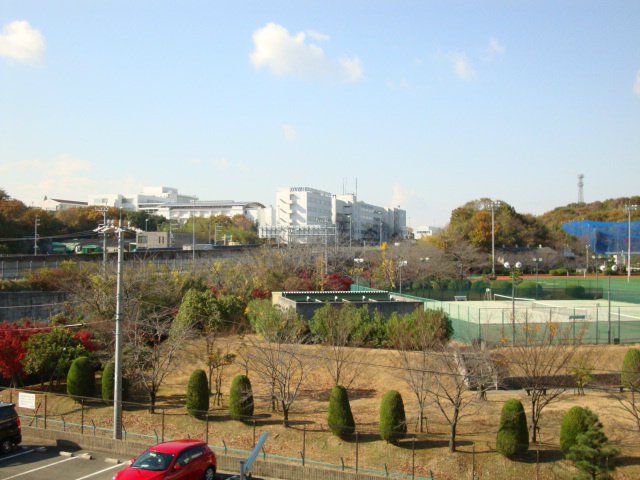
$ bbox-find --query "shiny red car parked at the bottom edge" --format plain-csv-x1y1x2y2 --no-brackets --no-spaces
113,440,218,480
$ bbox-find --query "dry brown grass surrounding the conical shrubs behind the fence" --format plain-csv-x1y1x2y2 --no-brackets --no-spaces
5,338,640,480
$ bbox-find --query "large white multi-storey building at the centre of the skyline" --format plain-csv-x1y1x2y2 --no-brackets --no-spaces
260,187,406,243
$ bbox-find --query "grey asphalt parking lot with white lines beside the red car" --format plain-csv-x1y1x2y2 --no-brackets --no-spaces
0,444,255,480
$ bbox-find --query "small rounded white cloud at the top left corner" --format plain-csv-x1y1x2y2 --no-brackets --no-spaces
0,20,47,62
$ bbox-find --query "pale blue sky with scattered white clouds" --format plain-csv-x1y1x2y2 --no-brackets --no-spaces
0,0,640,228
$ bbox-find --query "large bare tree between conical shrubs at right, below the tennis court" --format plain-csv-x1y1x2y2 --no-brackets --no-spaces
501,319,585,442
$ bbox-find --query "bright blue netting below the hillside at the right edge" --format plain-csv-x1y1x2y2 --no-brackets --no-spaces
562,220,640,255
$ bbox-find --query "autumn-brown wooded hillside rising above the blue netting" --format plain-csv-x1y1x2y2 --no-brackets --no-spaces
538,196,640,225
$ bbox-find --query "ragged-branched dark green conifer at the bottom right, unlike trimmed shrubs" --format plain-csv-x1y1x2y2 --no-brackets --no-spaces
567,408,620,480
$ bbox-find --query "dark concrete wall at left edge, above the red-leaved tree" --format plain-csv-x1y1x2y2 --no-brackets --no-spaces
0,292,69,322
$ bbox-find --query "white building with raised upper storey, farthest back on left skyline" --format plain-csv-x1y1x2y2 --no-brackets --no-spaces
89,187,198,213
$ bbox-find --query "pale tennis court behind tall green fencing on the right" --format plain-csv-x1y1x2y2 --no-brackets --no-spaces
425,295,640,344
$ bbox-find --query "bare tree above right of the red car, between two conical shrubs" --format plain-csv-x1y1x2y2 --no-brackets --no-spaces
246,308,313,427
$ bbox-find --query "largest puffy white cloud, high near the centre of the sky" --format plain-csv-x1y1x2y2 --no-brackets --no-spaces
249,23,363,82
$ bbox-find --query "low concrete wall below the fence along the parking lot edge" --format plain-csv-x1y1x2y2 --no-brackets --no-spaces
22,426,382,480
